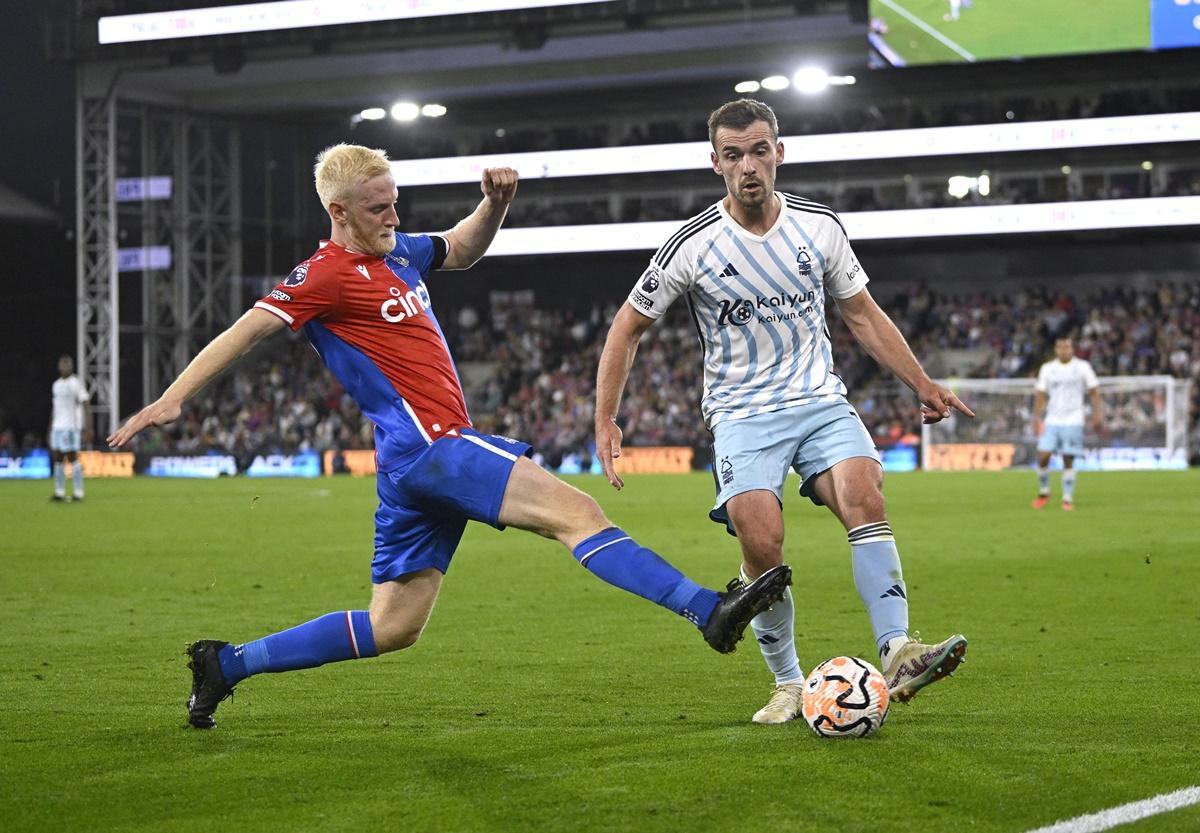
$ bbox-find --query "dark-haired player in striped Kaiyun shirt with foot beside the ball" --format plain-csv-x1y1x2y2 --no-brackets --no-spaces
595,98,974,723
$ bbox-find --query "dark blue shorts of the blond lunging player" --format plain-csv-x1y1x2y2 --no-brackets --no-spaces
371,429,532,585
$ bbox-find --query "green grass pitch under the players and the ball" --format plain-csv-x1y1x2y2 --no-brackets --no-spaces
0,471,1200,833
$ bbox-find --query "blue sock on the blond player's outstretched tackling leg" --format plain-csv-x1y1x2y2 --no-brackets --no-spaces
574,527,720,628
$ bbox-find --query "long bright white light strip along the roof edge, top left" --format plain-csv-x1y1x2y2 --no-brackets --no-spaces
96,0,608,43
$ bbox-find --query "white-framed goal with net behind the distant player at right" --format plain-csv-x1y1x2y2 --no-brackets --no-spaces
920,376,1190,471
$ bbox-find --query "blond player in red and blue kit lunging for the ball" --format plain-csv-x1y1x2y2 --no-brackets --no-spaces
108,144,791,729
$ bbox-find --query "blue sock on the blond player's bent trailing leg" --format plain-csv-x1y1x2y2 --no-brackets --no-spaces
217,610,378,685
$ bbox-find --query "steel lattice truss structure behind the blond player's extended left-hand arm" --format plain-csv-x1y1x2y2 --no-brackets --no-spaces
77,95,242,430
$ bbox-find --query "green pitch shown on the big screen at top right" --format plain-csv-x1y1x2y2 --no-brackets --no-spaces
870,0,1150,65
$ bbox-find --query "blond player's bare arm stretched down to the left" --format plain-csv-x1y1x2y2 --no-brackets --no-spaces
107,308,287,448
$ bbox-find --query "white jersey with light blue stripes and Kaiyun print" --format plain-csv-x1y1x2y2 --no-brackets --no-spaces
629,193,868,429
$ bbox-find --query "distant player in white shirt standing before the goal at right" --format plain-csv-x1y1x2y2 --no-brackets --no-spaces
1033,338,1104,511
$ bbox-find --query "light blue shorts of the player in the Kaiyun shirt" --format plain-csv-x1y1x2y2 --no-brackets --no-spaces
708,397,880,535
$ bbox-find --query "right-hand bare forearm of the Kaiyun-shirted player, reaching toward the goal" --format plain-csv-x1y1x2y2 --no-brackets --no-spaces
836,288,974,425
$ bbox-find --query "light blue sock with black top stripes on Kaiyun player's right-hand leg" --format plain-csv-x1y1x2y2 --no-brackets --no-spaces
847,521,908,649
